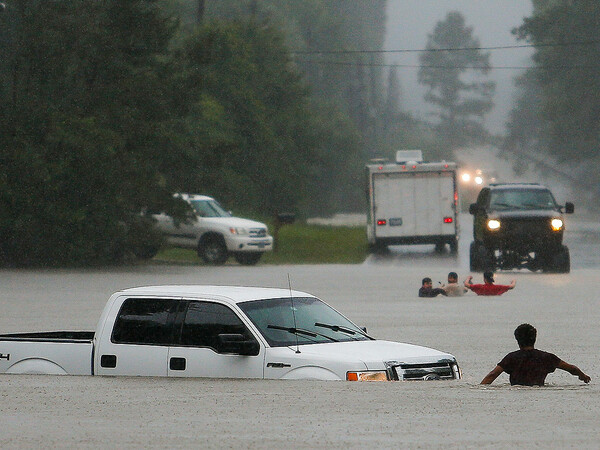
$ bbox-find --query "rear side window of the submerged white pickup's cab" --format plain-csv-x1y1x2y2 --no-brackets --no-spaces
111,298,177,345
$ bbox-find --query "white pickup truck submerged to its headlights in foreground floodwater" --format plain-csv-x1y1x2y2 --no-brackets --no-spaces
0,286,460,381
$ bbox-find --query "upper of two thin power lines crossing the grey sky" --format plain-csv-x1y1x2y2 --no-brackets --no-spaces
289,39,600,55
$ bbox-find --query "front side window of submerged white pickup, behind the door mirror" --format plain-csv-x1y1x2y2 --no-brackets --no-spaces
181,301,254,353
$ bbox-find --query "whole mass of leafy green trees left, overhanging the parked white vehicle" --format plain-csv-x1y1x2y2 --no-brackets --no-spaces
0,0,363,265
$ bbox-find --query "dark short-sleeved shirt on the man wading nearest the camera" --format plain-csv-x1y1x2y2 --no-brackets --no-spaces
498,348,560,386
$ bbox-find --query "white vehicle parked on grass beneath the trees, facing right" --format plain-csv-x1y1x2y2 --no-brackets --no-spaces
153,194,273,265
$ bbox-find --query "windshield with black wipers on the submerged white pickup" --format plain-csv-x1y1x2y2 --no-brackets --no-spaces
238,297,370,347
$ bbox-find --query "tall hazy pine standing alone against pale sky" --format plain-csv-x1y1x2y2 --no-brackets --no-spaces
419,12,495,148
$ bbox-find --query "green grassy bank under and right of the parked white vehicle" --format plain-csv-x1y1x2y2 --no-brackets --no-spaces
154,223,367,265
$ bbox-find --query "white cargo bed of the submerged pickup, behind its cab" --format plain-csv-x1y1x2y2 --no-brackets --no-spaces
0,331,94,375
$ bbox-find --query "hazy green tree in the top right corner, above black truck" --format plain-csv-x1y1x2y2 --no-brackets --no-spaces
515,0,600,160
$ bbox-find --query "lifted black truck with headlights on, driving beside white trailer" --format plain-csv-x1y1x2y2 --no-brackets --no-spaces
469,183,574,273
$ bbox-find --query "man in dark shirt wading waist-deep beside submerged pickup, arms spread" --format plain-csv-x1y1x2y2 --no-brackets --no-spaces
481,323,591,386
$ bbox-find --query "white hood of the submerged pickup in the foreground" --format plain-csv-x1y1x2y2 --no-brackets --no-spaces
282,340,455,370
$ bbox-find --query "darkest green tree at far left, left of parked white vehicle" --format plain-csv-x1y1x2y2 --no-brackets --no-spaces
0,0,185,265
